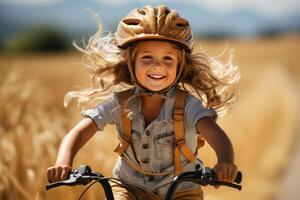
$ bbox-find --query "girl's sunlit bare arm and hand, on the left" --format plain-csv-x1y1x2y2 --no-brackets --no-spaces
47,118,98,182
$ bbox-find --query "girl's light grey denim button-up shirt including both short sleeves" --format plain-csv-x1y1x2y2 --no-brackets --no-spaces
81,88,216,195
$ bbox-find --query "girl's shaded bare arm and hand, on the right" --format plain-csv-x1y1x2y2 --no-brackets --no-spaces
196,117,237,182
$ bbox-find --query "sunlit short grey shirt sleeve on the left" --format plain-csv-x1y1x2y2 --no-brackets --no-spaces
81,94,119,131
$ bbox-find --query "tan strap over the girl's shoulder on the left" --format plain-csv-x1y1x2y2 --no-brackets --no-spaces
114,89,131,156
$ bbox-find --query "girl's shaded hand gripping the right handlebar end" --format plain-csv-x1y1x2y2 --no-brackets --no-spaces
213,162,238,189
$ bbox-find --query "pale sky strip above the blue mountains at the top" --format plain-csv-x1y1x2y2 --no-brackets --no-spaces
0,0,300,17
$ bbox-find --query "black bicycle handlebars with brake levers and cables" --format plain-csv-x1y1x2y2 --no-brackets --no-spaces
46,165,242,200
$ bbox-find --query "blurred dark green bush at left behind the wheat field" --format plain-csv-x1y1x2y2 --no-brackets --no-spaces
4,26,71,53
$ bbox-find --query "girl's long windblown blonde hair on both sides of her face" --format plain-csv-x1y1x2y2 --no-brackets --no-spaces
64,26,240,116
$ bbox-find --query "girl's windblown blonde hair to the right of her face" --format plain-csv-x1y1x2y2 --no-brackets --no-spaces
179,50,240,116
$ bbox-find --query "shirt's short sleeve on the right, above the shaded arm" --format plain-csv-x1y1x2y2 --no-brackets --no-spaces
185,95,217,127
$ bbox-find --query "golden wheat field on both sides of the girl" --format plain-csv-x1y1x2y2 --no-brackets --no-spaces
0,35,300,200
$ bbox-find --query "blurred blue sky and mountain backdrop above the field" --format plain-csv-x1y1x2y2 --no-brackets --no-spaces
0,0,300,40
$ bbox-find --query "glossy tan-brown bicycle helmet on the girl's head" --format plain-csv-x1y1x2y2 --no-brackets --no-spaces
115,5,194,53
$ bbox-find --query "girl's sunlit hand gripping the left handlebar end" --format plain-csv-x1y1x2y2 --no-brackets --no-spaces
47,165,72,183
